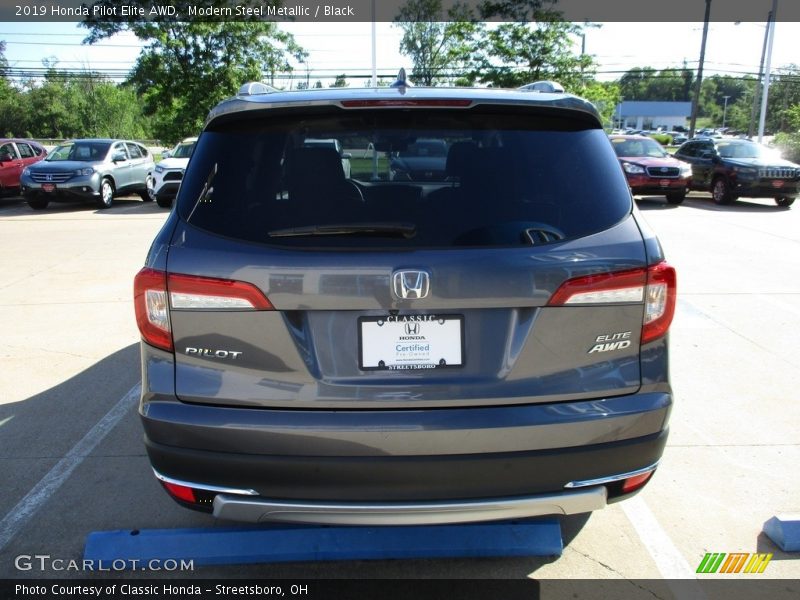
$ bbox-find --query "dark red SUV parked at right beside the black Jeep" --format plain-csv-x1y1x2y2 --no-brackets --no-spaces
610,135,692,204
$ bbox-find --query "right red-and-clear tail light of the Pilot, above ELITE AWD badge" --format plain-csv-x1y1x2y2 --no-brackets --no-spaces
547,262,677,344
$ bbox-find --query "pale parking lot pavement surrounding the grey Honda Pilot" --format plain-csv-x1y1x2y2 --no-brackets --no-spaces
0,194,800,585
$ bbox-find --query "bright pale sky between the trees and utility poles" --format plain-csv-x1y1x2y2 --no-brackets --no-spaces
0,22,800,86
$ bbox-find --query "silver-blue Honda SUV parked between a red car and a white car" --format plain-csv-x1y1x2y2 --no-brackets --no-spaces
20,139,155,210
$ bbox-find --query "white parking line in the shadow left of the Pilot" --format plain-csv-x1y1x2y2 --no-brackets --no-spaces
0,383,141,551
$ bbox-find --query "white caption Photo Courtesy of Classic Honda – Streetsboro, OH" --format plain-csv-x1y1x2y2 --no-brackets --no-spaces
14,583,308,598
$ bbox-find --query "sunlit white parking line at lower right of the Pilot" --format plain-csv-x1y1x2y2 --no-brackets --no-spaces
622,496,706,600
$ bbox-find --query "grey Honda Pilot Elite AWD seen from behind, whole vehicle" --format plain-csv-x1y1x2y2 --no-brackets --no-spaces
135,84,675,525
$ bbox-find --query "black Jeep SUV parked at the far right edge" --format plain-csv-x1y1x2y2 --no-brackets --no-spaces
675,138,800,206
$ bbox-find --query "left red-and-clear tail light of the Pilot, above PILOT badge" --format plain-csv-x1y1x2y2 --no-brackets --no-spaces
133,268,273,352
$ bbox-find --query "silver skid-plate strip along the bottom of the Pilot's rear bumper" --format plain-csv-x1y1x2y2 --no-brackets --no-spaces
214,487,607,525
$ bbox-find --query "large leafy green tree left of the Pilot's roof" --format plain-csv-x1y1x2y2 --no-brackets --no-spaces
82,12,306,143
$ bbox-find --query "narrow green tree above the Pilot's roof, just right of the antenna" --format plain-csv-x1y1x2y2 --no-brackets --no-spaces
395,0,485,86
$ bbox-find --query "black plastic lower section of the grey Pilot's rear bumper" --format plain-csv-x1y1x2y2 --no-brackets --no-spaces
145,412,667,502
